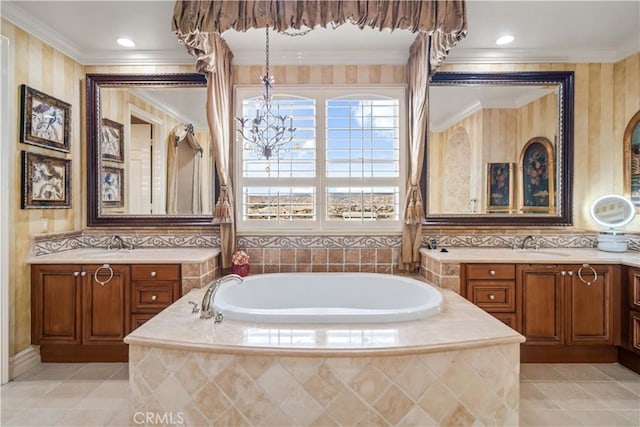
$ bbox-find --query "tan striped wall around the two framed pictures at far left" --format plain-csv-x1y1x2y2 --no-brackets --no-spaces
1,20,84,355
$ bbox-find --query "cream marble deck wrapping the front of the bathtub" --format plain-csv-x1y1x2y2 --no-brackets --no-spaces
124,289,524,356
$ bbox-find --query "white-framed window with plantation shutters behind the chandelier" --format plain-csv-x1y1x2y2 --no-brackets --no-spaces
233,86,407,232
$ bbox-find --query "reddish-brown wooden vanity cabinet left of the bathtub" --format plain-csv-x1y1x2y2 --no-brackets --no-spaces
31,264,181,362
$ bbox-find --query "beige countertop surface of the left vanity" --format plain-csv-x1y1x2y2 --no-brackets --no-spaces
27,248,220,264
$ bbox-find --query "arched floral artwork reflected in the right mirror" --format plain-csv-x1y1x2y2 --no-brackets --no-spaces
519,136,555,214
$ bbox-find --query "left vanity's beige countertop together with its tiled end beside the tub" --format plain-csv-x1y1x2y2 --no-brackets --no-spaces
27,247,221,295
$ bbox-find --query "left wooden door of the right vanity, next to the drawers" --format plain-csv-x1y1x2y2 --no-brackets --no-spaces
517,264,564,345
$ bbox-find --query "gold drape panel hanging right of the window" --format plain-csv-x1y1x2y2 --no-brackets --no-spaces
401,33,429,270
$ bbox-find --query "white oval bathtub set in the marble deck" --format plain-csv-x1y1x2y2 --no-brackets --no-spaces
214,273,442,323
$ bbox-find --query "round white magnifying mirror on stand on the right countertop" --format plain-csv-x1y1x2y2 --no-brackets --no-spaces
590,195,636,252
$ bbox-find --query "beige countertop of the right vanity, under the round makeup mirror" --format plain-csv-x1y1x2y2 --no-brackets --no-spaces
420,248,640,267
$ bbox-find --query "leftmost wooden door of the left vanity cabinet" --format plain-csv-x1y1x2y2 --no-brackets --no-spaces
31,265,82,344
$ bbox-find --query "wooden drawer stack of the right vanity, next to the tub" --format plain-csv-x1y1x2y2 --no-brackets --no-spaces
461,264,519,330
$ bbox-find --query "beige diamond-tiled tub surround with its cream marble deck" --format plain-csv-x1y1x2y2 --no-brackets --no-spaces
125,290,523,426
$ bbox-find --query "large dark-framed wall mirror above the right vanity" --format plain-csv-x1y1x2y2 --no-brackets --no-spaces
422,72,574,226
